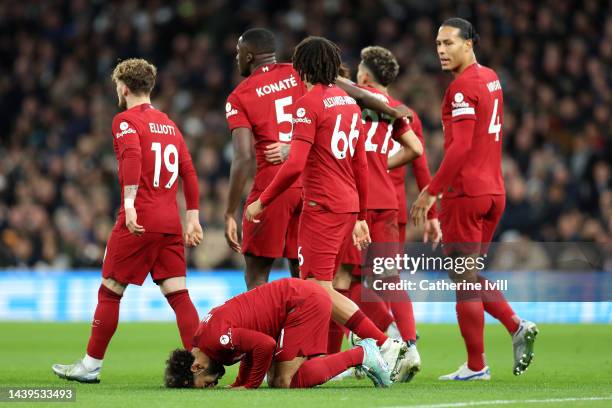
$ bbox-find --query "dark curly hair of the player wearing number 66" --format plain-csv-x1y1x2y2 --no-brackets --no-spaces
293,36,342,85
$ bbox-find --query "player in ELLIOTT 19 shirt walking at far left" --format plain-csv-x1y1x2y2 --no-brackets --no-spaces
53,59,202,383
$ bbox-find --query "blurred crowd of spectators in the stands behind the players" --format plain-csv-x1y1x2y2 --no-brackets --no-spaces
0,0,612,268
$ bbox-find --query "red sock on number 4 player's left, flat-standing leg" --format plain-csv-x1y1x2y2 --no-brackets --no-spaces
456,291,485,371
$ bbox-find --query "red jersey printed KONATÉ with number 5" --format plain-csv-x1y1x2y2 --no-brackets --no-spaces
225,64,306,191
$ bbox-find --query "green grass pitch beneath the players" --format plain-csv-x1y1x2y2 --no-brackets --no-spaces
0,323,612,408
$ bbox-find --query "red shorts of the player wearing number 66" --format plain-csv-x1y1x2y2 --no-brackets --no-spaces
298,203,357,281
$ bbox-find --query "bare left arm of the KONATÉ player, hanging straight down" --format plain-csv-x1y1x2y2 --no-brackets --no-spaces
225,128,255,253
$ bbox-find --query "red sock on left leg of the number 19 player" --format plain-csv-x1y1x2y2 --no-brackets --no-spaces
87,285,122,360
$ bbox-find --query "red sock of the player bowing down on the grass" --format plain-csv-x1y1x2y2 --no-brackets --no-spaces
291,347,363,388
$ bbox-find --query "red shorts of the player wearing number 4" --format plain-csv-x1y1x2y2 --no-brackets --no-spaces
440,195,506,255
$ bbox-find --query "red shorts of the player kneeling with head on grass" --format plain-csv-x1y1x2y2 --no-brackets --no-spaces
274,281,332,361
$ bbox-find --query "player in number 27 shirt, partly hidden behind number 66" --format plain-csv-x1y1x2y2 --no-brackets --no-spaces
330,47,423,381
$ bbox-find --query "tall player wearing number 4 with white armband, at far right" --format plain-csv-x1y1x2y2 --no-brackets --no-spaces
411,18,538,380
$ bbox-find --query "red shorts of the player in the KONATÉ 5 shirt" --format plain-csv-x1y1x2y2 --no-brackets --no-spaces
242,188,302,259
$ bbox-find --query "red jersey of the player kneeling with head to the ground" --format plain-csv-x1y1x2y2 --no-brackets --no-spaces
193,278,311,365
